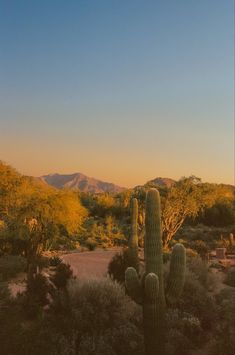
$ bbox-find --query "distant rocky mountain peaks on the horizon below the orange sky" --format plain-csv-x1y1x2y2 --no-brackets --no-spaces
40,173,175,193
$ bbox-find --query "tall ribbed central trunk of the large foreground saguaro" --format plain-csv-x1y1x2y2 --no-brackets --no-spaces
143,189,166,355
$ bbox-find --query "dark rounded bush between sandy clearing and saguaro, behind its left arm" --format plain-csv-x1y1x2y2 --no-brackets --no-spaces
108,249,139,283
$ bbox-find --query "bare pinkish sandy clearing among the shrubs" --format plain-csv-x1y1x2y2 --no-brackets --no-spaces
61,249,120,278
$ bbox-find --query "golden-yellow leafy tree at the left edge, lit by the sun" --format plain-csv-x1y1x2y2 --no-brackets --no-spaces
0,162,87,257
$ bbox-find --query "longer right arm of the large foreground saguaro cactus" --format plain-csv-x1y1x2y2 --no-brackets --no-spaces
166,243,186,304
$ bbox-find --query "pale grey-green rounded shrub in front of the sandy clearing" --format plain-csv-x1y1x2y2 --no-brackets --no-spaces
68,279,143,355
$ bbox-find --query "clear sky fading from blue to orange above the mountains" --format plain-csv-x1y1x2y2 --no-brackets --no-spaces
0,0,234,187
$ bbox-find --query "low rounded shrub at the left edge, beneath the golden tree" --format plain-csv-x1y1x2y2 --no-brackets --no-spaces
0,255,26,280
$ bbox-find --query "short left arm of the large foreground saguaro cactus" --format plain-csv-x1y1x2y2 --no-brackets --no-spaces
125,267,143,304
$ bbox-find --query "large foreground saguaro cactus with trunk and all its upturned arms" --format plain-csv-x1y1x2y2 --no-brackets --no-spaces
125,189,186,355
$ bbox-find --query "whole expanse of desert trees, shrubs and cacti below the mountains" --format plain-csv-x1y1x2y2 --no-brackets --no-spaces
0,163,235,355
